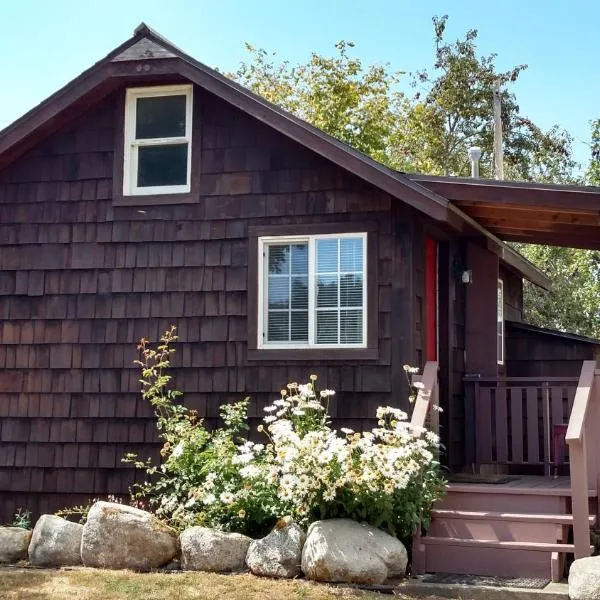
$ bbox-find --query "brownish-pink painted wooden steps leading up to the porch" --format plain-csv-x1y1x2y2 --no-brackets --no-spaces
413,477,598,581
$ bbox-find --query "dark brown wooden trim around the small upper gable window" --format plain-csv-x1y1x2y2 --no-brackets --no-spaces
112,81,202,206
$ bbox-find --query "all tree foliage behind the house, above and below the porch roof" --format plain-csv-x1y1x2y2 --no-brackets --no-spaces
230,16,600,336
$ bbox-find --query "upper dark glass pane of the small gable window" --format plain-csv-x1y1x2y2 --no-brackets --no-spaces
135,96,186,140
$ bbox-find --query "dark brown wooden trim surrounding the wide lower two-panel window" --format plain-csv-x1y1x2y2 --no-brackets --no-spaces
247,222,379,362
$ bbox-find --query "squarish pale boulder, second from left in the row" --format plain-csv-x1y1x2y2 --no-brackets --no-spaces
29,515,83,567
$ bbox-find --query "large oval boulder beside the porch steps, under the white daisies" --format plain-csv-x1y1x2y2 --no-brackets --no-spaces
302,519,408,584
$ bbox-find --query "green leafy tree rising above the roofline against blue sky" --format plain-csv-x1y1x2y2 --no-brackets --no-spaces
230,16,576,181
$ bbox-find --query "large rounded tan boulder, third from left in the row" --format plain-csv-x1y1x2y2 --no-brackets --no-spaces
81,502,178,571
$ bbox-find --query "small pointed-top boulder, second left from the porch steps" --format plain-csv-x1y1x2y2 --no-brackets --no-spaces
246,520,306,578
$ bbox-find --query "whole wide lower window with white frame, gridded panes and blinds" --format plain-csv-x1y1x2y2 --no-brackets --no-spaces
258,233,368,349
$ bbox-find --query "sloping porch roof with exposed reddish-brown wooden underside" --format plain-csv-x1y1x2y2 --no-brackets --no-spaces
407,174,600,250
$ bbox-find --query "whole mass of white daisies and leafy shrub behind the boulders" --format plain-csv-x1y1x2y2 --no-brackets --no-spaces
125,329,445,538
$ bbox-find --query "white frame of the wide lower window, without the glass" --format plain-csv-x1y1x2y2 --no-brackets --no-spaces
257,232,369,350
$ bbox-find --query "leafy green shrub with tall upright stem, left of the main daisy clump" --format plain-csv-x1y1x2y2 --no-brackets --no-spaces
123,327,278,534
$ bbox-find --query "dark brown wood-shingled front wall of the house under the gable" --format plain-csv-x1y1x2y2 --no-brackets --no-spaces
0,82,406,522
